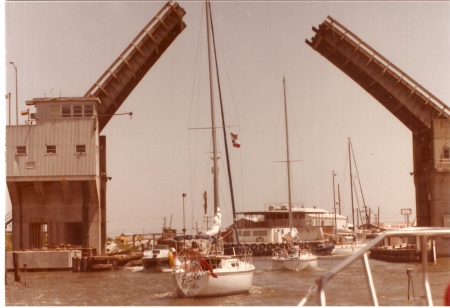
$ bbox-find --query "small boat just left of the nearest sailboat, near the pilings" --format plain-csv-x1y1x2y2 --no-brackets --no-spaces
141,245,175,272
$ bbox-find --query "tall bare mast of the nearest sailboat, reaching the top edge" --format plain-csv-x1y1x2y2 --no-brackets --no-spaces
205,0,219,215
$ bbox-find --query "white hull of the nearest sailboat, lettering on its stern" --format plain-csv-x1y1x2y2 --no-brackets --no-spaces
173,261,255,297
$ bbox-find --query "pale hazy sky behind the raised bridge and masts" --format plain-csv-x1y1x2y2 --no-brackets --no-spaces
3,1,450,236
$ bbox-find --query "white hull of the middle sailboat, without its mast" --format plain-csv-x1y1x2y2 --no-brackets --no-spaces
272,246,317,272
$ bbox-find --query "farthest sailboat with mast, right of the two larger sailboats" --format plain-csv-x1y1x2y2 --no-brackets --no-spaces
333,138,367,256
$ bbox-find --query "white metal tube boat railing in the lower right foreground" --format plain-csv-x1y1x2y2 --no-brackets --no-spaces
299,227,450,306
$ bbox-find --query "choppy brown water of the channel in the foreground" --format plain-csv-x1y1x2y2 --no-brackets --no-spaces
5,257,450,306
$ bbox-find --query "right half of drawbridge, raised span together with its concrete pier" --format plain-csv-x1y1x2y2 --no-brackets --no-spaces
305,16,450,254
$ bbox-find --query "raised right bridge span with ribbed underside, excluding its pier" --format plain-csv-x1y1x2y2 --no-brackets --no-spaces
306,17,450,134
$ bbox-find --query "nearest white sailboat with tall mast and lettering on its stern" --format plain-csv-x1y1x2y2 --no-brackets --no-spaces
172,1,255,297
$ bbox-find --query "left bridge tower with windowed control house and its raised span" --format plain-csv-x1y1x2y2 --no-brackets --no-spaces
6,1,186,254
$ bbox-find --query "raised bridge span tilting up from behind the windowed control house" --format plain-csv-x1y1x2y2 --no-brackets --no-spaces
84,1,186,132
